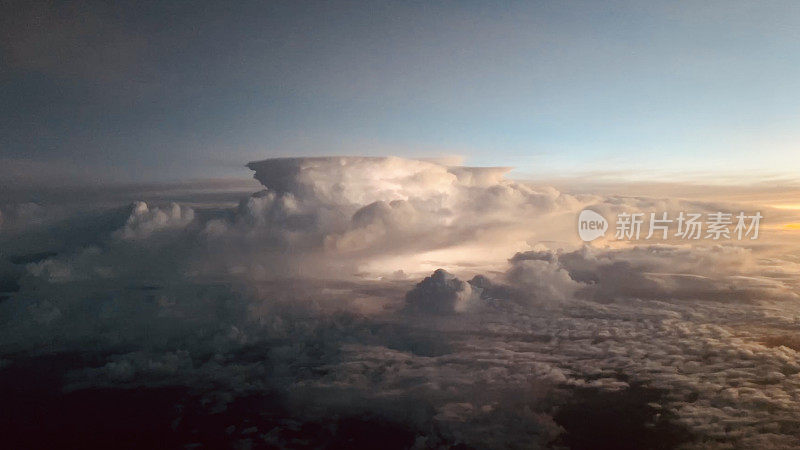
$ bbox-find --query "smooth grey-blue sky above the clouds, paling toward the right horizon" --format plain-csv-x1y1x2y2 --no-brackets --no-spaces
0,1,800,184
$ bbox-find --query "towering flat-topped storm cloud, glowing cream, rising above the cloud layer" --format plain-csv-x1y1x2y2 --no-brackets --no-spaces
227,157,586,276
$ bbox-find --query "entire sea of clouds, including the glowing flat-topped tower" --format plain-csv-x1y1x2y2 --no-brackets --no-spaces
0,158,800,448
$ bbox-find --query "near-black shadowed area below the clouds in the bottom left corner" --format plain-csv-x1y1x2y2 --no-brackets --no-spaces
0,353,424,449
